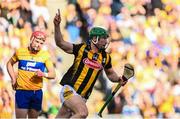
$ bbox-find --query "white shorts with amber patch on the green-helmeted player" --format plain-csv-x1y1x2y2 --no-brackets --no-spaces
60,85,80,104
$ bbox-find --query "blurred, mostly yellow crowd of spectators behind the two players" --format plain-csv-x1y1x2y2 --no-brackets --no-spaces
0,0,180,119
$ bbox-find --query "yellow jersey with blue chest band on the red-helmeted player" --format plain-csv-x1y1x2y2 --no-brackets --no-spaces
12,48,53,90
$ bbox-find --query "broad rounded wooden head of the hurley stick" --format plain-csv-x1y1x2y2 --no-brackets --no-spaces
122,64,134,81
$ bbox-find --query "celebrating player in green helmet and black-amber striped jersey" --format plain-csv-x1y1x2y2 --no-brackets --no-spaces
54,10,134,118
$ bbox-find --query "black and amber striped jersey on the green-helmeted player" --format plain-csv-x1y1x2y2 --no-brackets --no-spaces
60,43,112,99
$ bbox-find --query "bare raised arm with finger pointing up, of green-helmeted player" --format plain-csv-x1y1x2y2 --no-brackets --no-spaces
54,9,73,54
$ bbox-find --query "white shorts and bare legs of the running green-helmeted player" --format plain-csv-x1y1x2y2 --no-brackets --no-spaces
57,85,88,118
